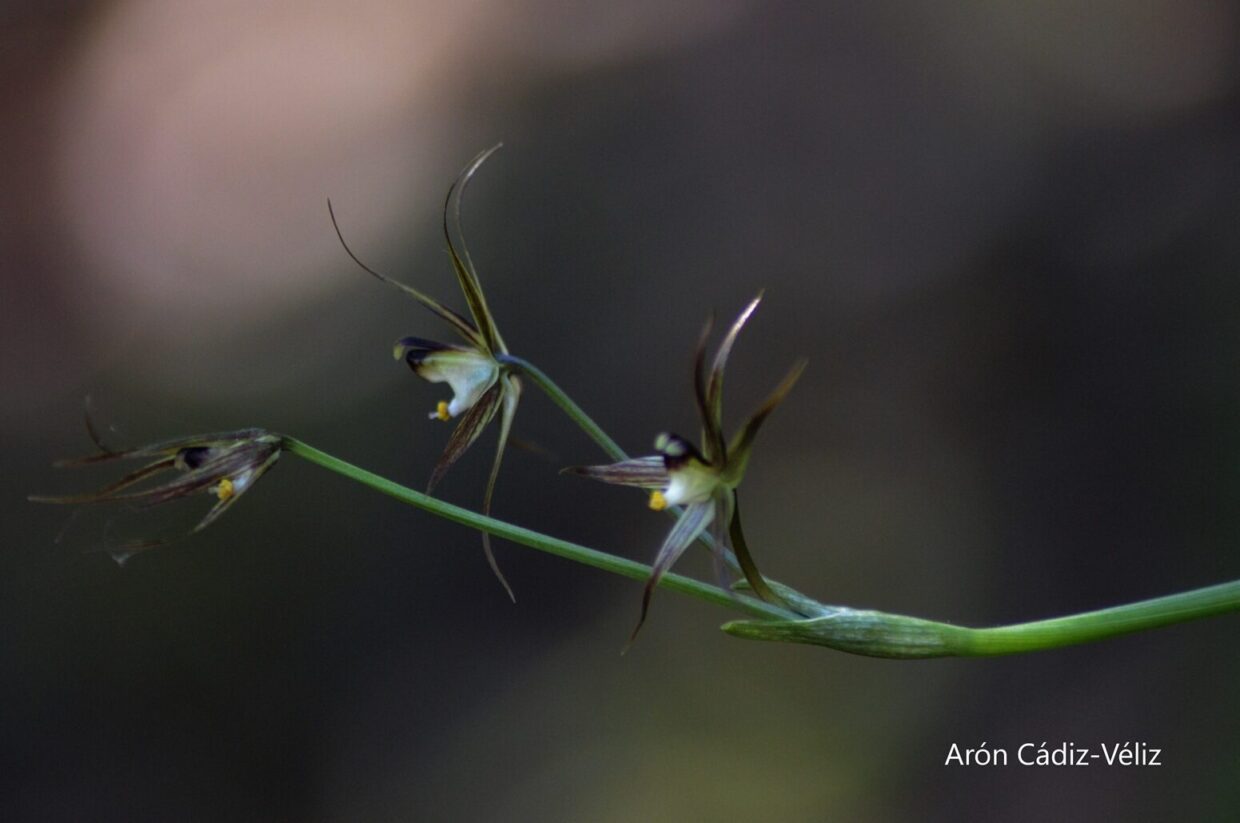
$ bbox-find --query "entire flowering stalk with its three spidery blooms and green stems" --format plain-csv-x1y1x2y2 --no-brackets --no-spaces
30,146,1240,659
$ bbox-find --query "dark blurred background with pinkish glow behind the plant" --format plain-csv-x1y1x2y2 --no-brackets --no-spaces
7,0,1240,821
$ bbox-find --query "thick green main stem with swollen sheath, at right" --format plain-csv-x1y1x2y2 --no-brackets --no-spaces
723,580,1240,658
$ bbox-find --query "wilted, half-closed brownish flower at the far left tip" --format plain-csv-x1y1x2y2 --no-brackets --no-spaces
30,418,284,563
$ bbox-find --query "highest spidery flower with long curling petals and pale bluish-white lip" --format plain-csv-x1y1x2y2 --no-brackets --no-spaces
327,144,521,601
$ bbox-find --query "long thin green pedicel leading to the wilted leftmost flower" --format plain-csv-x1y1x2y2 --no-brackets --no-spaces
284,435,795,620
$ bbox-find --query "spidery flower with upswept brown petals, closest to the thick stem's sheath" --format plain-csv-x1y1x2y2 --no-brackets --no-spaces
565,295,806,642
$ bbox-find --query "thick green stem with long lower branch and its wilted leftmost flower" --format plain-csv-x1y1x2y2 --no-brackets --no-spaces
30,421,1240,659
